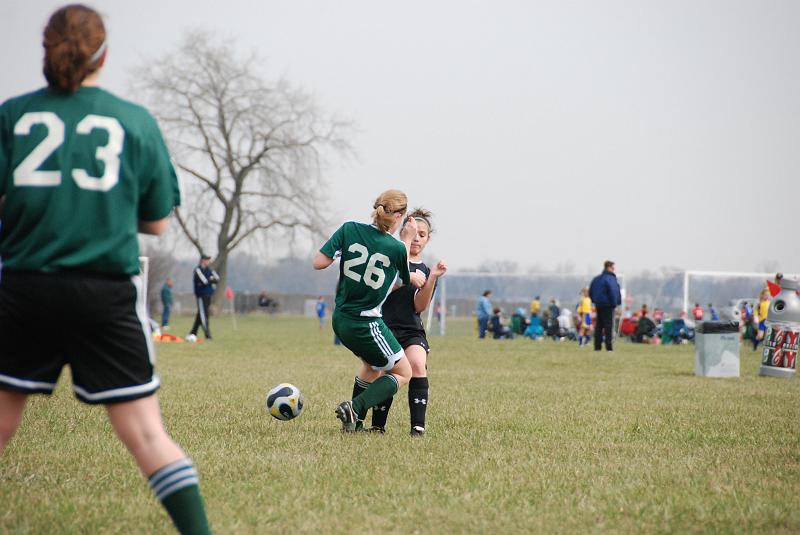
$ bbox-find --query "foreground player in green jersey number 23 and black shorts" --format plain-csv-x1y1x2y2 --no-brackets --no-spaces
0,4,210,533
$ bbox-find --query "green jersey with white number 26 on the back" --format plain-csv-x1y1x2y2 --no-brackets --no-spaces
320,221,410,318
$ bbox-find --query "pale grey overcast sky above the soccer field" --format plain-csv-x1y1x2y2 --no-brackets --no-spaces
0,0,800,272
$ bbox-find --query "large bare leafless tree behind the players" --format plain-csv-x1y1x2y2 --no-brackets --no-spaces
134,31,351,304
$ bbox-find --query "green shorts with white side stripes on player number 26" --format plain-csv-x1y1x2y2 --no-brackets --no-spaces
333,311,405,372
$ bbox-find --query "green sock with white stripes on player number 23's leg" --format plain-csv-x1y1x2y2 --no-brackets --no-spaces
149,459,211,535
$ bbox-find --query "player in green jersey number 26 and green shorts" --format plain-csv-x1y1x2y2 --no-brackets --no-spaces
314,190,417,432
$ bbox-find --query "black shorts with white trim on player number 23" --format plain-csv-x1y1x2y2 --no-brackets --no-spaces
0,271,160,404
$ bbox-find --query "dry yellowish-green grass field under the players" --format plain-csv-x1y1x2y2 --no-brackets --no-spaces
0,316,800,534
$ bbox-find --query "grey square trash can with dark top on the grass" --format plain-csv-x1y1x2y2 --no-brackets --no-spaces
694,321,739,377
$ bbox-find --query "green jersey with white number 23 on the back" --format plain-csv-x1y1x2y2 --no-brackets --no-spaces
0,87,180,275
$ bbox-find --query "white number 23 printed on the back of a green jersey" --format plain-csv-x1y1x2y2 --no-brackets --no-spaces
14,111,125,191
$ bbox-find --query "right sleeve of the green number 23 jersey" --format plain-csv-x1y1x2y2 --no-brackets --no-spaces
139,114,181,221
